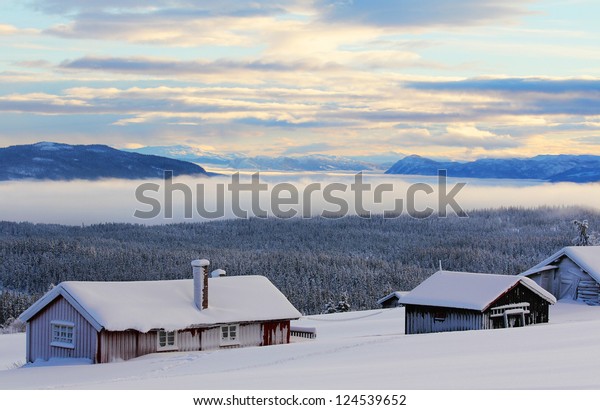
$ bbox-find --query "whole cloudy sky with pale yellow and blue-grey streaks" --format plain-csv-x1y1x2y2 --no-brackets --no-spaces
0,0,600,159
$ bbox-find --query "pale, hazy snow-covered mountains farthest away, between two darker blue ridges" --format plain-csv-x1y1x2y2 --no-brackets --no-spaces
125,145,384,172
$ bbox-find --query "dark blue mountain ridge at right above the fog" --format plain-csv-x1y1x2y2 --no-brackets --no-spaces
385,155,600,182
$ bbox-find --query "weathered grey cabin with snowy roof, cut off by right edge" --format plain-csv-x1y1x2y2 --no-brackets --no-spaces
521,246,600,306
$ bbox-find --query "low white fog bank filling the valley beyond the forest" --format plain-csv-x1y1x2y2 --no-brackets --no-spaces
0,172,600,225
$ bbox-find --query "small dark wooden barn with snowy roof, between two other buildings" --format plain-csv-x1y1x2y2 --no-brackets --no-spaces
402,271,556,334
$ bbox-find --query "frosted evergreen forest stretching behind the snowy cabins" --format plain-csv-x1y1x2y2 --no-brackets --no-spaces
0,207,600,325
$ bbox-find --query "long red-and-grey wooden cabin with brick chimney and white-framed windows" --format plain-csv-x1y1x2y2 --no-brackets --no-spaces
20,260,301,363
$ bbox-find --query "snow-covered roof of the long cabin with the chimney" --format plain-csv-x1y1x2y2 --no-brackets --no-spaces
20,276,302,332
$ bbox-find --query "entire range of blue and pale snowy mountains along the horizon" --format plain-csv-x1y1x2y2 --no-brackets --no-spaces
0,142,600,183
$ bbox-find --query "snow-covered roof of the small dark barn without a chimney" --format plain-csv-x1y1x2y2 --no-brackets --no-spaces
402,271,556,312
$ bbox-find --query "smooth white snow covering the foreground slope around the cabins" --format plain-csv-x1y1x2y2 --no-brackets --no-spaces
0,302,600,390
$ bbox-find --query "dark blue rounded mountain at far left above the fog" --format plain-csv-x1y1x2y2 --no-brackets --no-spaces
0,142,207,181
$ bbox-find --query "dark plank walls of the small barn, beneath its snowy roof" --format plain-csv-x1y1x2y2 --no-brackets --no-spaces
405,283,549,334
